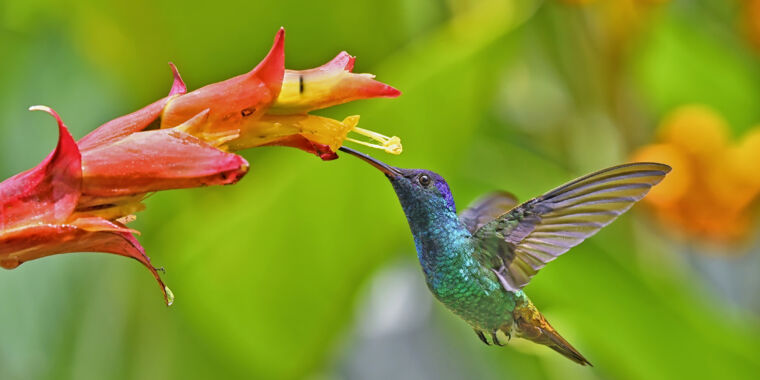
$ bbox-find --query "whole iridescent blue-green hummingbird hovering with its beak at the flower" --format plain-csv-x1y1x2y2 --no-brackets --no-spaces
340,147,671,365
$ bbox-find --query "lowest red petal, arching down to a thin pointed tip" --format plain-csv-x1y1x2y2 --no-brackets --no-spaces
0,218,173,305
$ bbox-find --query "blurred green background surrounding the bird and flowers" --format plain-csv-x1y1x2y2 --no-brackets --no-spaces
0,0,760,380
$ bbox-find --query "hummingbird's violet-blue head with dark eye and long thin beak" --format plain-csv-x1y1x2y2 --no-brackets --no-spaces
340,147,456,216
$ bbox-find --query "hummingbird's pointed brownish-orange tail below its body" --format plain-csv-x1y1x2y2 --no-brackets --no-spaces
511,299,591,365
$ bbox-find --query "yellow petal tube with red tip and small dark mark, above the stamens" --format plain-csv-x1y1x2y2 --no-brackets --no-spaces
268,52,401,115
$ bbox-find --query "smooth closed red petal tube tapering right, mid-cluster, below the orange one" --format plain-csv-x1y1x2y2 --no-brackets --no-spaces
82,129,248,197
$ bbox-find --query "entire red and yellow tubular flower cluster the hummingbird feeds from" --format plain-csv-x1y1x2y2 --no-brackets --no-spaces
0,29,401,304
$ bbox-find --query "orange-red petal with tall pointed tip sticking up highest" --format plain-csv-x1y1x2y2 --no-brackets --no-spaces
161,29,285,130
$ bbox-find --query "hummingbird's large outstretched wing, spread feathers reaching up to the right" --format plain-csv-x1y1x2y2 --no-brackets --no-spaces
473,163,670,291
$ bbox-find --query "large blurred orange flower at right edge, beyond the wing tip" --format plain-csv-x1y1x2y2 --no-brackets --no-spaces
633,105,760,244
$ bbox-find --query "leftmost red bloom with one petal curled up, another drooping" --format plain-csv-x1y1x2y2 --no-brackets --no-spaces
0,106,173,304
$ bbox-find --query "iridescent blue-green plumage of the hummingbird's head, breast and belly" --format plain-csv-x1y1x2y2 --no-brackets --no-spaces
391,170,515,331
